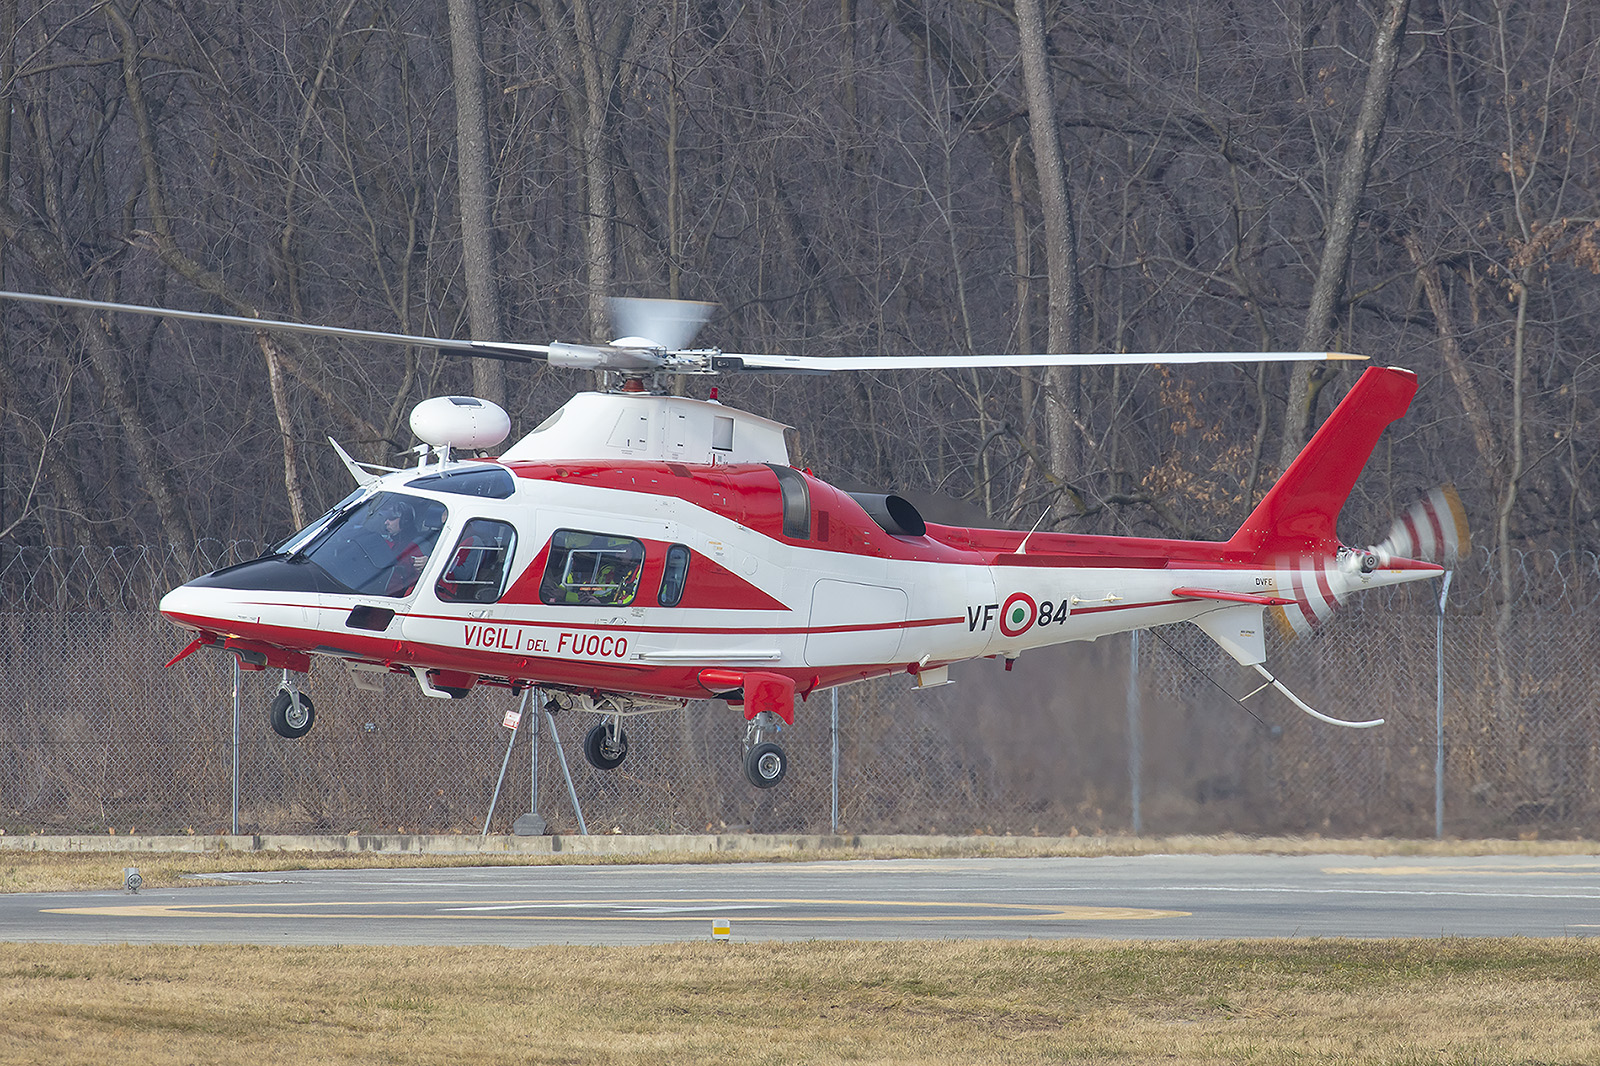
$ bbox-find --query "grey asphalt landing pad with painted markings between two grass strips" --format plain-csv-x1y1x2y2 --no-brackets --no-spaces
0,855,1600,946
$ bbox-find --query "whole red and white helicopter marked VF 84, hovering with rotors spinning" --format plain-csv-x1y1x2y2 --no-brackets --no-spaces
0,286,1464,787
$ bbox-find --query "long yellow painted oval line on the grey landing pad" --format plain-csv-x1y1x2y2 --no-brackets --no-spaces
45,896,1190,924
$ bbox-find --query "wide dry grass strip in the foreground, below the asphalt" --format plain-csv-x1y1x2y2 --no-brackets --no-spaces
0,940,1600,1066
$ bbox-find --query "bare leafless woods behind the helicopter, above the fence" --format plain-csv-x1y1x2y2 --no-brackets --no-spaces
0,0,1600,832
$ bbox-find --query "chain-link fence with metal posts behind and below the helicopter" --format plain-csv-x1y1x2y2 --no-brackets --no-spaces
0,544,1600,837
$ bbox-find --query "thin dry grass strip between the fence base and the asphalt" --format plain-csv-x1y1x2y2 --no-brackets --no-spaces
0,836,1600,892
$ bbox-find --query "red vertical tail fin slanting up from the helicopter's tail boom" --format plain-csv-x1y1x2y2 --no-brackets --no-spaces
1227,367,1416,555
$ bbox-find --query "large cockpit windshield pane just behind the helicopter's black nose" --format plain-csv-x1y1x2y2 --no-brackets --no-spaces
304,493,448,597
